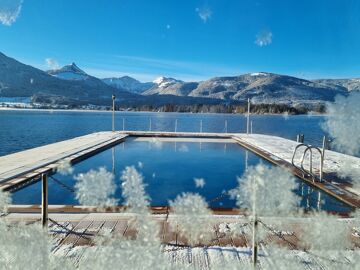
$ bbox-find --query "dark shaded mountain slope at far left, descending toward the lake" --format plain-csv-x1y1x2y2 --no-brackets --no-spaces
0,53,137,104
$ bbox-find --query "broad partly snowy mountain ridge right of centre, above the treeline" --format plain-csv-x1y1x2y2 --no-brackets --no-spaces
144,72,347,104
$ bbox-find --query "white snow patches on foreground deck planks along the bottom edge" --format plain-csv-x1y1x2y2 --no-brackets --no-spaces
52,245,355,270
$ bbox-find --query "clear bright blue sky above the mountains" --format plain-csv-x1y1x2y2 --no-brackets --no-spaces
0,0,360,81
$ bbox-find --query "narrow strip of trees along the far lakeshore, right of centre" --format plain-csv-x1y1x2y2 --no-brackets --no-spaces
128,101,325,114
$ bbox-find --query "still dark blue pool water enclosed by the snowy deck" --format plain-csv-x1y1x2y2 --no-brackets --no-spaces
13,138,350,212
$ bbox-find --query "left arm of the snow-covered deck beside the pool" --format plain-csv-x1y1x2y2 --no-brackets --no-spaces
0,132,127,191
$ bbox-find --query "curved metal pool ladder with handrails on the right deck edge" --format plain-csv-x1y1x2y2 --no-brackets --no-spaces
291,136,328,182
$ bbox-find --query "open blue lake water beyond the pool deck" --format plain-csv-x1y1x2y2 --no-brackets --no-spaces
0,110,324,156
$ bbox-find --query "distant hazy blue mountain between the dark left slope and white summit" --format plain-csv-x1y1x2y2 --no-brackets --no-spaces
102,76,154,93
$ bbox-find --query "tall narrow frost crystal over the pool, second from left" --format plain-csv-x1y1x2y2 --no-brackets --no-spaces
121,166,150,213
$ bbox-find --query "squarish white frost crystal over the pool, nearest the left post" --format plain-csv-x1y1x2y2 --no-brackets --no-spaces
75,167,117,208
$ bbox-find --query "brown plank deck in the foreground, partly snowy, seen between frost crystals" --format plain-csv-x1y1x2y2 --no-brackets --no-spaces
4,213,360,269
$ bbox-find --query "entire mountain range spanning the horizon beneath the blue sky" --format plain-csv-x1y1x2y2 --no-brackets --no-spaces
0,53,360,106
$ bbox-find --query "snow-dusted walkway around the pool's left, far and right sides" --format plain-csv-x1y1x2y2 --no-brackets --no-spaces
0,131,360,207
